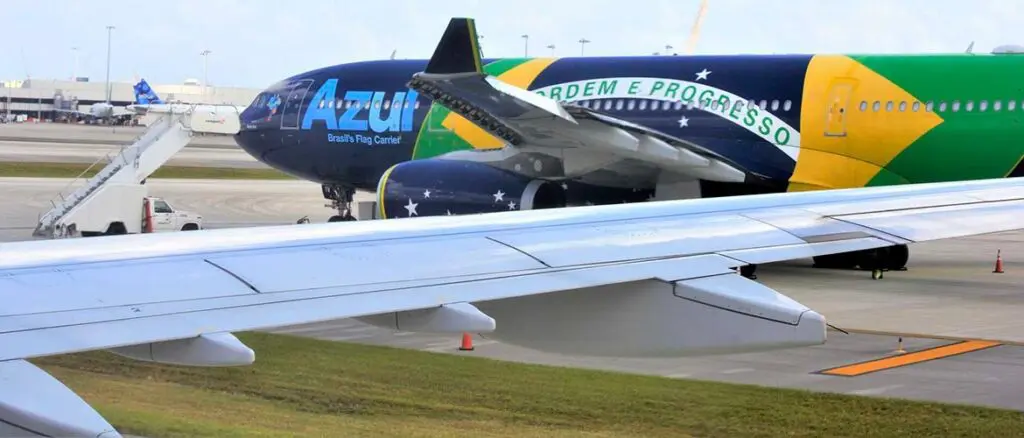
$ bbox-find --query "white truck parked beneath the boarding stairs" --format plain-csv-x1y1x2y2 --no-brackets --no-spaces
58,183,203,237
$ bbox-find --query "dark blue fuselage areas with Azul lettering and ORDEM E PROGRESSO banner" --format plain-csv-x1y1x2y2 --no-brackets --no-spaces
236,55,810,191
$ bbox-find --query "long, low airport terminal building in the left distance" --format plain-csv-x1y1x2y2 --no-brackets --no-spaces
0,78,260,122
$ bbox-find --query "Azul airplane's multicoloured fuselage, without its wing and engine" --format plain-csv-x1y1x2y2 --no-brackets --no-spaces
237,54,1024,196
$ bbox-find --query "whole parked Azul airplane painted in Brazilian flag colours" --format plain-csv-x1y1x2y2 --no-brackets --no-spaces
236,19,1024,276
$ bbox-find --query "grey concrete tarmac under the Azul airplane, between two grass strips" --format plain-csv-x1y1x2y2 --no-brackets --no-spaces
0,173,1024,410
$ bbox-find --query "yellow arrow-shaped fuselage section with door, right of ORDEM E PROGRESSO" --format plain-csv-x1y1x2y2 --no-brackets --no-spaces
790,55,942,191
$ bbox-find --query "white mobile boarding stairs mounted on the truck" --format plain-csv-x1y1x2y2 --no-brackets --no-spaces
32,104,243,238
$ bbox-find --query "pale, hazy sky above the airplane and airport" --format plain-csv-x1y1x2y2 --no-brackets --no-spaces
0,0,1024,88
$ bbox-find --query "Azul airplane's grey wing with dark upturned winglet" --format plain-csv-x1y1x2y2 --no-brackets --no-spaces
409,18,767,183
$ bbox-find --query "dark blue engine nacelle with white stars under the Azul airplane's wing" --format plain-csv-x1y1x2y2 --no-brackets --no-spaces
377,159,653,219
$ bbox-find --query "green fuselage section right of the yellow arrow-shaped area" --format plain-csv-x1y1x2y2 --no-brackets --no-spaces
853,54,1024,185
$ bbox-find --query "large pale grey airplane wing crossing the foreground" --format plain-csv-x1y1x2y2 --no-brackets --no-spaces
0,178,1024,436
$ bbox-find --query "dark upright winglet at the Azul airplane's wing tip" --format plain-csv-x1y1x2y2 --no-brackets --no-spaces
424,18,483,75
